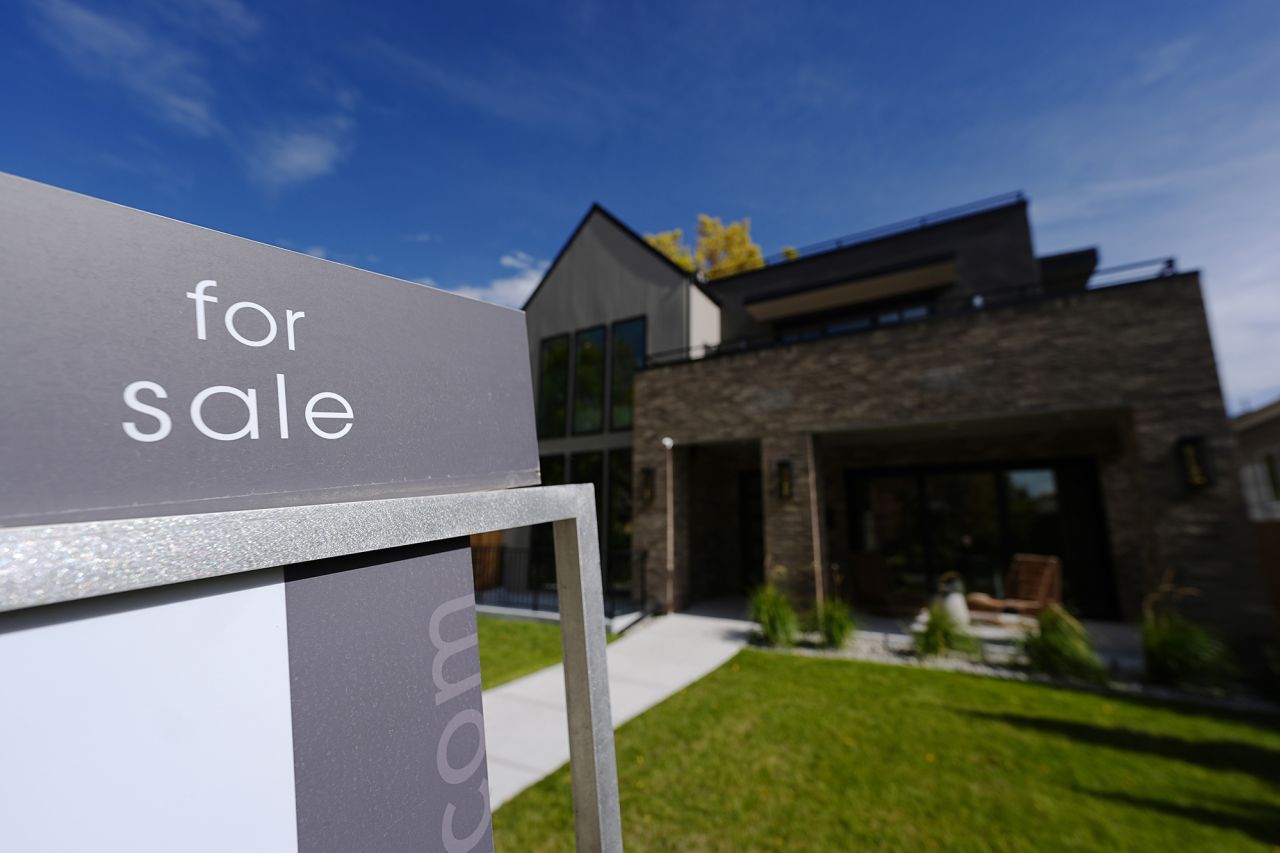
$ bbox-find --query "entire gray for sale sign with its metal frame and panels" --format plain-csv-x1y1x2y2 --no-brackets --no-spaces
0,175,622,853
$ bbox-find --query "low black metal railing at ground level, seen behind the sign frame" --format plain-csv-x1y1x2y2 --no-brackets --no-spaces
471,544,646,619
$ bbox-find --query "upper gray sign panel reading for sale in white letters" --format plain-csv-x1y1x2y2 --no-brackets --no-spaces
0,174,538,525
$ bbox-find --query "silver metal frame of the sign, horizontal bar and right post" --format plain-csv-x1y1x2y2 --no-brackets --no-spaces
0,484,622,853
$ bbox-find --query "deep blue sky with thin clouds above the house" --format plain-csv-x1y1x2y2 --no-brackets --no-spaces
0,0,1280,409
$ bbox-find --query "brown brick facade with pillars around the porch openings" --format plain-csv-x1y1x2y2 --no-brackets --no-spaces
634,273,1271,637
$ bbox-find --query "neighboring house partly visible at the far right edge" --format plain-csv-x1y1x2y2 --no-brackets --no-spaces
1231,400,1280,612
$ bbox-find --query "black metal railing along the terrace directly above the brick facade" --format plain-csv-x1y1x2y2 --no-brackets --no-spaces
641,257,1178,369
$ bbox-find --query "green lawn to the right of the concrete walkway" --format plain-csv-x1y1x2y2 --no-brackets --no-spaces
494,651,1280,852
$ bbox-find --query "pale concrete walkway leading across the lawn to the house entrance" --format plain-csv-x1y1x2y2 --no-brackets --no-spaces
484,613,751,809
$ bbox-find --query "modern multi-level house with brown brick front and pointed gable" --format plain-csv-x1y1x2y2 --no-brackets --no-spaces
525,195,1271,645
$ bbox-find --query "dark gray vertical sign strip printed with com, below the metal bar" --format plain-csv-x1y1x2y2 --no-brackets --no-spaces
284,539,493,853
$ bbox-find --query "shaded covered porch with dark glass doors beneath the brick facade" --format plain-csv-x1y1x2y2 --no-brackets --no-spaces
640,407,1146,621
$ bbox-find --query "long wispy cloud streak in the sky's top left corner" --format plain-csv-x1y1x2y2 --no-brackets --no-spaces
32,0,220,136
